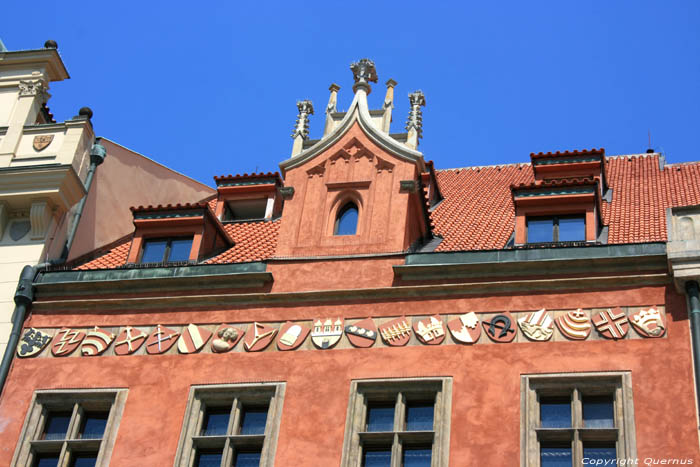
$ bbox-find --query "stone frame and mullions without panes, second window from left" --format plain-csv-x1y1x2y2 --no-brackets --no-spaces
174,382,286,467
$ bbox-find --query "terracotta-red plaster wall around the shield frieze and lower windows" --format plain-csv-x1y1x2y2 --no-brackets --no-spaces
0,280,700,466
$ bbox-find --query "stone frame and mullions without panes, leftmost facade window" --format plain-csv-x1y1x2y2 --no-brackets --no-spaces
11,389,128,467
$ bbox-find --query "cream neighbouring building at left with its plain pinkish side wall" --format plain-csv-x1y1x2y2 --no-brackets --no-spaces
0,41,213,355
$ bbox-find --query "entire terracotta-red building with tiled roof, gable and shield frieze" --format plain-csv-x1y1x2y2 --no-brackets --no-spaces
0,59,700,467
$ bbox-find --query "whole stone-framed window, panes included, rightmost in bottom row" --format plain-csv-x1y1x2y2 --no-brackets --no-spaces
520,372,636,467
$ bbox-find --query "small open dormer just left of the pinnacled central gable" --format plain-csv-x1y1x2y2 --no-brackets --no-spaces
214,172,284,222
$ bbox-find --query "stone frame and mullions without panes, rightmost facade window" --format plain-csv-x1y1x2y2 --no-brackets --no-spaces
520,371,637,467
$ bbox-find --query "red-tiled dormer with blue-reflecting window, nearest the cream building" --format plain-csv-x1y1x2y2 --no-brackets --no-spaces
127,203,234,264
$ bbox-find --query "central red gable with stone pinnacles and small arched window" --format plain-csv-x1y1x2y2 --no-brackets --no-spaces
277,59,439,257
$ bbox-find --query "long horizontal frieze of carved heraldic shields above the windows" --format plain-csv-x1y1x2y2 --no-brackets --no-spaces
17,306,667,358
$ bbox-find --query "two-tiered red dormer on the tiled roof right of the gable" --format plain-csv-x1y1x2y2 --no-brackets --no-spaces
511,149,612,246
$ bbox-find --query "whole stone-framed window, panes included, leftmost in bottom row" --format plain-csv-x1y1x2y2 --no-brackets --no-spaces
12,389,127,467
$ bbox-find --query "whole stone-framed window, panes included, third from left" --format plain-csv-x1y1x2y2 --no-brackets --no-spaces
341,377,452,467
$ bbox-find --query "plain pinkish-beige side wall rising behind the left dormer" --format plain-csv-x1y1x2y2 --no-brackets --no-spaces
68,139,216,259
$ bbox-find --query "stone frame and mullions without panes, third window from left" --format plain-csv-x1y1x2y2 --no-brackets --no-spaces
340,377,452,467
